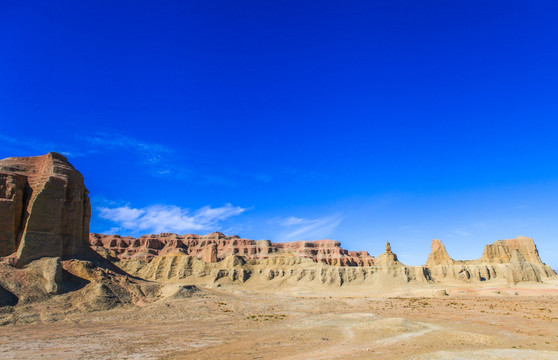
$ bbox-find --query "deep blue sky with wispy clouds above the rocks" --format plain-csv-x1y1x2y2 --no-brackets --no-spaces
0,1,558,268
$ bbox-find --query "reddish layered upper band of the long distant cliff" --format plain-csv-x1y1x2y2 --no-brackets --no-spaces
89,232,374,266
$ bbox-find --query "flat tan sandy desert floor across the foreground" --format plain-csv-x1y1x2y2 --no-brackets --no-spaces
0,283,558,360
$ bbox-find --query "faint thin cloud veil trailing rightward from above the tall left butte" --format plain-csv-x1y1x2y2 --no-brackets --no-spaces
0,131,306,187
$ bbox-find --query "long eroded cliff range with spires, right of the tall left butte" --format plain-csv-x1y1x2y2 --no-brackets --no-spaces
90,233,556,287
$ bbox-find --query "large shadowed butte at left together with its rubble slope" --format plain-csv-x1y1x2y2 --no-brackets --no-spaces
0,153,157,311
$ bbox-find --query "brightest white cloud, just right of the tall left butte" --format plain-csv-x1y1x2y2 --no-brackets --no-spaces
99,204,246,233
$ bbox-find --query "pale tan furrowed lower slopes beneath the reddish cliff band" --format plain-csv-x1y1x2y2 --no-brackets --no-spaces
117,254,434,288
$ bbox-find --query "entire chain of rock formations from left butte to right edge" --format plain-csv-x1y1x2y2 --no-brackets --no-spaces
0,153,557,309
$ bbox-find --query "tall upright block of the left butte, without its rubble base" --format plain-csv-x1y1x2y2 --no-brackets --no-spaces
0,152,91,266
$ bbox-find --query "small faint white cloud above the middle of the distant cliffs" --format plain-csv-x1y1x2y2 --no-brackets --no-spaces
276,214,343,241
